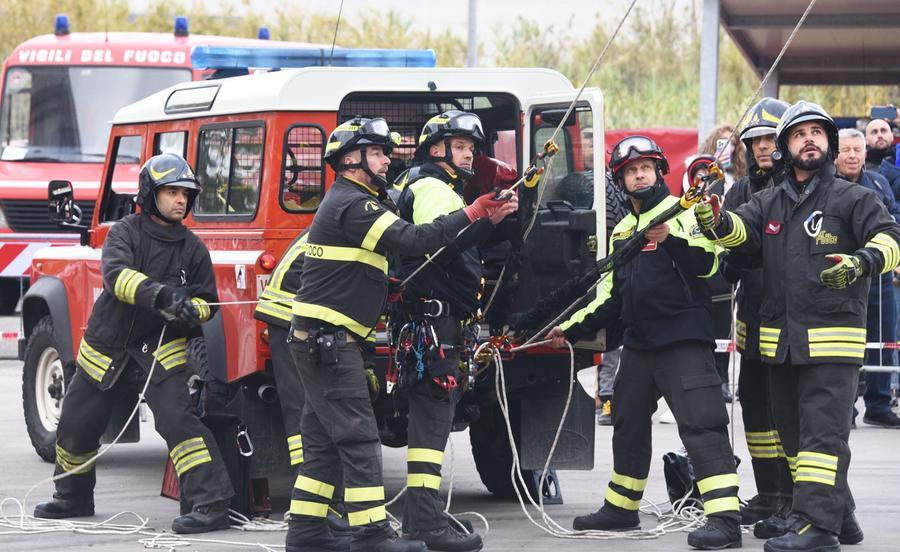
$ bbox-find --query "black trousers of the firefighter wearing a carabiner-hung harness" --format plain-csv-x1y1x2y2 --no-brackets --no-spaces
403,317,462,533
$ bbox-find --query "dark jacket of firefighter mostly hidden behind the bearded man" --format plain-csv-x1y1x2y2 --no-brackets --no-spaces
721,174,774,359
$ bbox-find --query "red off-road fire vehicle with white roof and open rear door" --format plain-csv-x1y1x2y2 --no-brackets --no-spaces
20,61,696,502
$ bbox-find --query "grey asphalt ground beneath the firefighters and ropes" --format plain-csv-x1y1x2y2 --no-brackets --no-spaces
0,312,900,552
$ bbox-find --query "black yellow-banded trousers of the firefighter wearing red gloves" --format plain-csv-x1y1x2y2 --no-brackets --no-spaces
289,332,389,545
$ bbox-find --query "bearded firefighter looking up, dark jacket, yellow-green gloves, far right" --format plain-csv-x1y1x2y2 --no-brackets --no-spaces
695,101,900,552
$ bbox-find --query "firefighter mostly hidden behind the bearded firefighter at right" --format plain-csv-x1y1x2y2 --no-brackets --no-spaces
721,98,793,538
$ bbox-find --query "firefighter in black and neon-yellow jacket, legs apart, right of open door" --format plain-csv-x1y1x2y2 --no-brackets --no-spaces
548,136,741,550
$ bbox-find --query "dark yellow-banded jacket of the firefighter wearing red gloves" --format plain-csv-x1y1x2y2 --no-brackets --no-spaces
292,176,469,339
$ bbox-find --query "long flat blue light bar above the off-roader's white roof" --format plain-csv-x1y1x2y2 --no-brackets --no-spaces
191,46,437,69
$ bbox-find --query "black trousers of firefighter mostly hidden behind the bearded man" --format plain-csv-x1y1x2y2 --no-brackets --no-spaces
738,356,794,500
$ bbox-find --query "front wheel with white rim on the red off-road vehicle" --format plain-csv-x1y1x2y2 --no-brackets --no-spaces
22,316,75,462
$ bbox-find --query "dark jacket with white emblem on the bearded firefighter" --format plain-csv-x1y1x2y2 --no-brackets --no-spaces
719,163,900,364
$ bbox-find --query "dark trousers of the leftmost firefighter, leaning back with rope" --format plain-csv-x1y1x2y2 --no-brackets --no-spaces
54,361,234,506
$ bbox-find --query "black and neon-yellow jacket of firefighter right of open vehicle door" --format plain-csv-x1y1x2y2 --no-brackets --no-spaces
560,185,718,349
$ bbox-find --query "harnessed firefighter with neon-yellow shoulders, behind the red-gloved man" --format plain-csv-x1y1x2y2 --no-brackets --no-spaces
392,110,510,551
